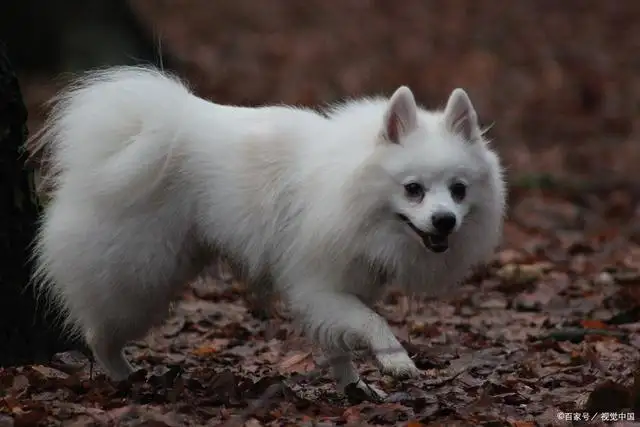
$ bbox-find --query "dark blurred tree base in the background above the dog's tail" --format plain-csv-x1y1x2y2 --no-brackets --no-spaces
0,0,170,73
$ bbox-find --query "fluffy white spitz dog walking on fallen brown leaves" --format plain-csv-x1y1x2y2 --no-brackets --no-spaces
34,67,506,400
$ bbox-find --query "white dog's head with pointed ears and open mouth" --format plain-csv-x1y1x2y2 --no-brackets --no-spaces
380,86,505,253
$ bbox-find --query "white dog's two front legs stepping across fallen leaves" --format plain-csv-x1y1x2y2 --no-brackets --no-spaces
289,288,420,398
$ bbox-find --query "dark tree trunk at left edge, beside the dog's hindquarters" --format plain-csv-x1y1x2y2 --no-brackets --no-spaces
0,42,84,366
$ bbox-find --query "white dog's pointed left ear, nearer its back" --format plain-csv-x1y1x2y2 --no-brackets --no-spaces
383,86,418,144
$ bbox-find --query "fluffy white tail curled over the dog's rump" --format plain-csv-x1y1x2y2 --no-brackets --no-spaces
29,67,191,204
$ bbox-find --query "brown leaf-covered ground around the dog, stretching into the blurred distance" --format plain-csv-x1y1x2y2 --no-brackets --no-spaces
5,0,640,427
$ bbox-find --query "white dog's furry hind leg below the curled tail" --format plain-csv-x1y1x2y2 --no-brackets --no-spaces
41,211,209,380
